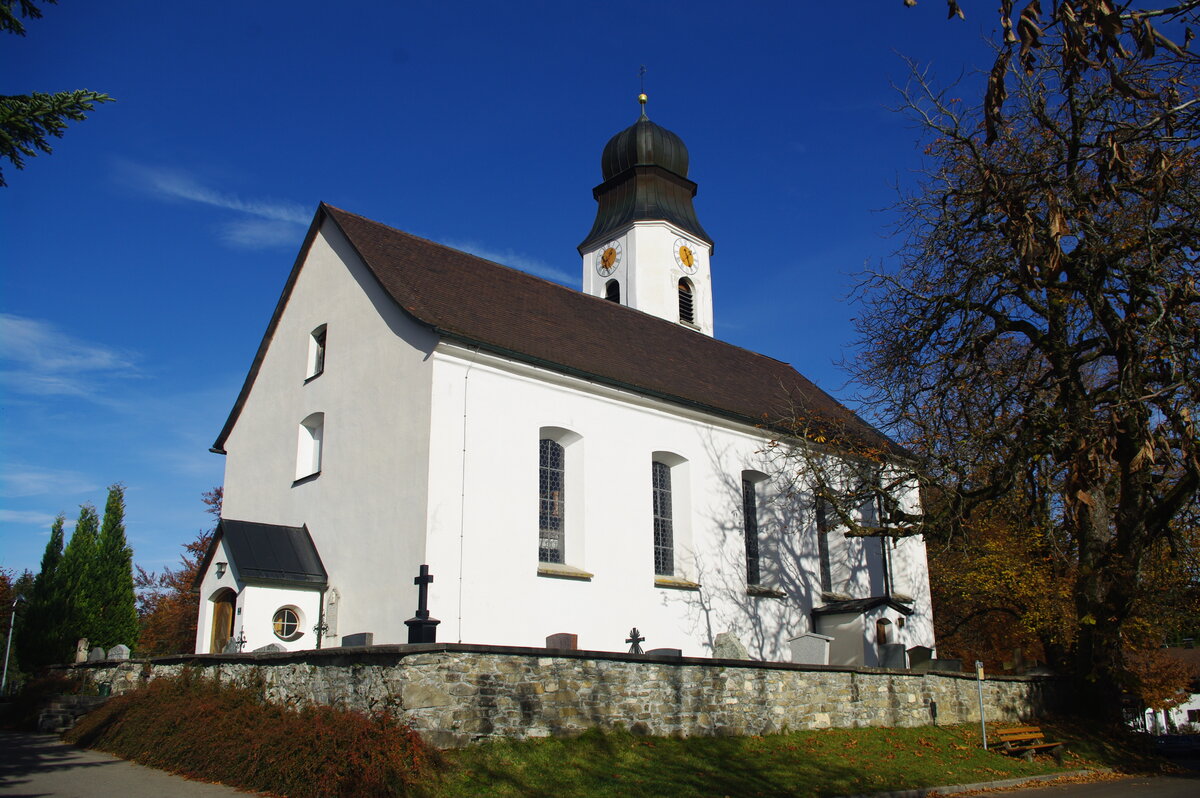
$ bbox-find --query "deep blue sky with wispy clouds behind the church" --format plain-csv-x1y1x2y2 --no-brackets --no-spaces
0,0,995,571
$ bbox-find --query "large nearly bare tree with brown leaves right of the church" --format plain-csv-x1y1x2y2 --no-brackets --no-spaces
852,0,1200,709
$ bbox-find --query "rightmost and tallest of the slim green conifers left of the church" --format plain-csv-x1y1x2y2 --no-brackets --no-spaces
91,485,138,649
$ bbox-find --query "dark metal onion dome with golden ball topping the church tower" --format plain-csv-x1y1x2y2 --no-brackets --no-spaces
578,95,713,254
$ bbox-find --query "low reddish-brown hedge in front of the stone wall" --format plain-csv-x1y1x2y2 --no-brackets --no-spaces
66,673,439,798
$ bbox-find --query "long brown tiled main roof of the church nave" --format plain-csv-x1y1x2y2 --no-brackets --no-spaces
214,203,902,454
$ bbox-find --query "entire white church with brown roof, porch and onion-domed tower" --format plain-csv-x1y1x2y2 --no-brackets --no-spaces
196,102,934,666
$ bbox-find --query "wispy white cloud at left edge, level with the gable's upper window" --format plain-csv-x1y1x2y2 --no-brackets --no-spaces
0,313,138,396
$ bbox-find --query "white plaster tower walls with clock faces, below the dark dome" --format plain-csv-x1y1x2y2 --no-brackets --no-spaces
583,221,713,335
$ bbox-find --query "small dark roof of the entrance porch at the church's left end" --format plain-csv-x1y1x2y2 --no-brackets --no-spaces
196,518,329,587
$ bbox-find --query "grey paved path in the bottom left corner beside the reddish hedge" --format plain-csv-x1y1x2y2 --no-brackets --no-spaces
0,732,253,798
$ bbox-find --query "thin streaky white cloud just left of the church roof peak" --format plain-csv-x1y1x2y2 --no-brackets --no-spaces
121,163,310,250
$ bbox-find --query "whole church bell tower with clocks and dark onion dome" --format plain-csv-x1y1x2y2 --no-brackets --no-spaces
578,94,713,336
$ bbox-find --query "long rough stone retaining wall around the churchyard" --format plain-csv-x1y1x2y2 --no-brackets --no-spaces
65,643,1061,748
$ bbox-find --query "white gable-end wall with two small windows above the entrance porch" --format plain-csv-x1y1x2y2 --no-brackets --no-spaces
216,221,434,644
